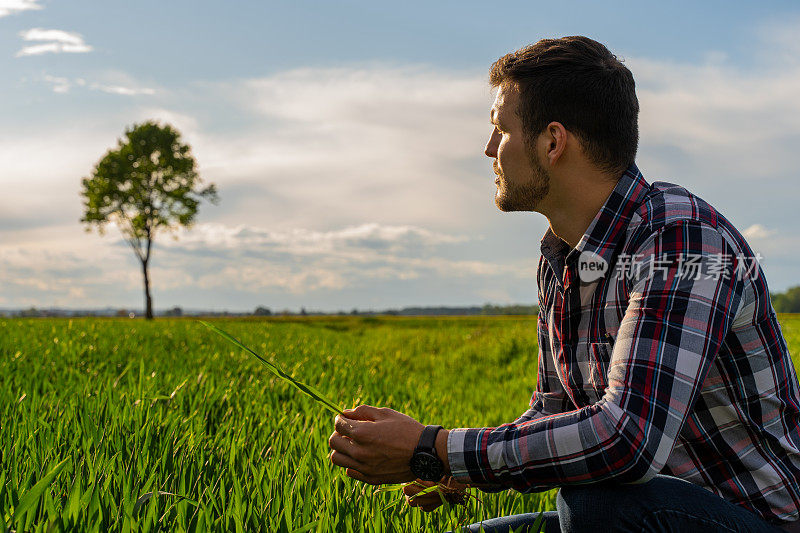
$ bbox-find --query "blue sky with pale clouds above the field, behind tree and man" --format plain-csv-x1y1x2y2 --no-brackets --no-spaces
0,0,800,311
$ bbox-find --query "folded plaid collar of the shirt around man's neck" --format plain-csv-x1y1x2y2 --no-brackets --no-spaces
541,164,650,274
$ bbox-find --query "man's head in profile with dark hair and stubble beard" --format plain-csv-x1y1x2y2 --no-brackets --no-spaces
486,36,639,211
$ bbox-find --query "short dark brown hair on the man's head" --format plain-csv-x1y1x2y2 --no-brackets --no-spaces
489,36,639,173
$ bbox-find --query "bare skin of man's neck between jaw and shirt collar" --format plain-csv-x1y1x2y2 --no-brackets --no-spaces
537,168,617,248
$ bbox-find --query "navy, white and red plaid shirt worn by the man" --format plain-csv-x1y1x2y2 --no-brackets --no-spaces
448,166,800,522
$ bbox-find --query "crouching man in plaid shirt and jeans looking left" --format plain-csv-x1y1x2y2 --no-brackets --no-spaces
330,37,800,532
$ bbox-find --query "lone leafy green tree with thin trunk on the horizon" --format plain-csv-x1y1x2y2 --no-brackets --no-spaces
81,121,218,319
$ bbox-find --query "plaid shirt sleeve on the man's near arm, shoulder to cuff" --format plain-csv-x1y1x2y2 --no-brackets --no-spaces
447,220,743,492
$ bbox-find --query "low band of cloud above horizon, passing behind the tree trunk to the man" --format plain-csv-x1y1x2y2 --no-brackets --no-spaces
0,223,535,306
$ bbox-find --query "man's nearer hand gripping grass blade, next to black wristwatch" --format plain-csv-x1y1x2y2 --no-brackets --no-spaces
328,405,425,485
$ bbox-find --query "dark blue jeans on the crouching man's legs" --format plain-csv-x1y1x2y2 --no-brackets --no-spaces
454,476,783,533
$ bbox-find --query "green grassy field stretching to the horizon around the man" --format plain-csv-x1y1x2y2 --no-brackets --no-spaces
0,315,800,532
